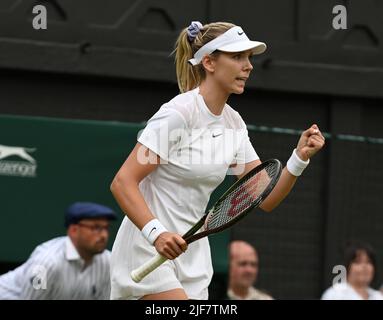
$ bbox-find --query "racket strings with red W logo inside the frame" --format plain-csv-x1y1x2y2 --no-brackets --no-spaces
205,164,278,230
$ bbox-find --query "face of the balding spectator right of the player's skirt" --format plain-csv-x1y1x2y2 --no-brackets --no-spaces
230,244,258,288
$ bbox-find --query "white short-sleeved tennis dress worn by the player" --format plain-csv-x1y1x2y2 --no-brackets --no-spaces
111,88,258,299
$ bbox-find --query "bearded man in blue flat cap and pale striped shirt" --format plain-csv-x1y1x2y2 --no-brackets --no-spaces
0,202,116,300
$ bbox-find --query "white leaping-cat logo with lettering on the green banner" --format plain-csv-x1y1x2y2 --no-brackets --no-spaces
0,144,37,177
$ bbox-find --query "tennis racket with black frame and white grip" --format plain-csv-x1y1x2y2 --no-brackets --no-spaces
130,159,282,282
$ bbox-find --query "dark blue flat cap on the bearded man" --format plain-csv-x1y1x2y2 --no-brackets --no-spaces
65,202,117,227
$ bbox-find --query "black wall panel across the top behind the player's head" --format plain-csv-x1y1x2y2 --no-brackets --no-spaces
0,0,383,97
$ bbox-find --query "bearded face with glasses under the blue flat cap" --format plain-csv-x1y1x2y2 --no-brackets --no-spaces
71,218,109,255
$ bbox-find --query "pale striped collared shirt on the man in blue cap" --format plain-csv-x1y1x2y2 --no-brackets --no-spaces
0,237,110,300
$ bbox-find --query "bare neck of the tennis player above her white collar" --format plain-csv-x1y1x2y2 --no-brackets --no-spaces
199,81,229,116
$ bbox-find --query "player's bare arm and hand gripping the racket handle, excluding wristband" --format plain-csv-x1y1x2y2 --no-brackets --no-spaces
110,142,187,259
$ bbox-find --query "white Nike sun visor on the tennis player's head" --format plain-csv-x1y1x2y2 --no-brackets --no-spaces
189,26,266,66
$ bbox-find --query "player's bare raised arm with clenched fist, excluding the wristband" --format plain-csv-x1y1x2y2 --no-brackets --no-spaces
232,124,325,212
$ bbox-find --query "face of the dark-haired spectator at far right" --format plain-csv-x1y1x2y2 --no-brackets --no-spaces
348,250,374,286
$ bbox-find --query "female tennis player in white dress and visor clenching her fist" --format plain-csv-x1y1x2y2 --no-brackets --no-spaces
111,22,324,299
